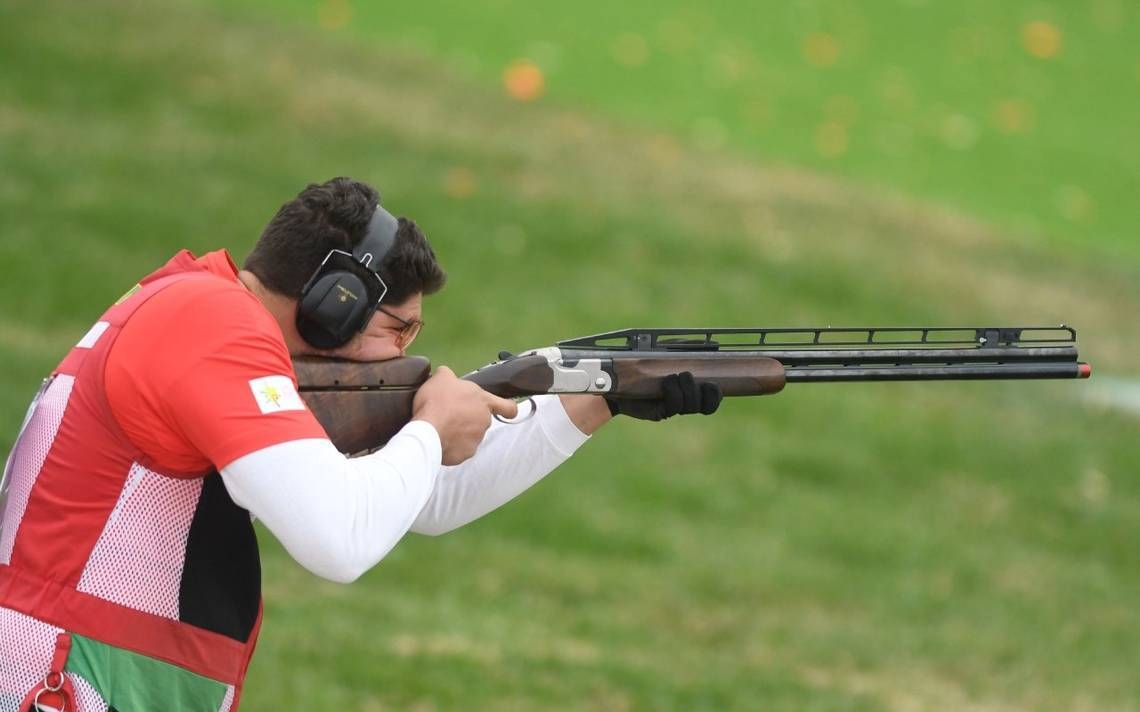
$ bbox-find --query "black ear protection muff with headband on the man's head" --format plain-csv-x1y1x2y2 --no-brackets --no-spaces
296,205,400,349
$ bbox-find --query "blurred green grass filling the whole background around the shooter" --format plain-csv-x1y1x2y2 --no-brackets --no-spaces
0,0,1140,711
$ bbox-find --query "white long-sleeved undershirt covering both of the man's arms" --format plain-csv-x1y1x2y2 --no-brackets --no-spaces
221,395,588,583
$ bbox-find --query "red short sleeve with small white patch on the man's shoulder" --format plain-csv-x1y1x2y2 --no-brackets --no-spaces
105,268,324,472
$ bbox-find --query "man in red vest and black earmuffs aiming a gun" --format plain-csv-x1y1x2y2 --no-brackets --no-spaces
0,178,720,712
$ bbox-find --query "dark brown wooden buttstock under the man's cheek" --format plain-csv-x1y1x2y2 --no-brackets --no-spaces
293,357,431,455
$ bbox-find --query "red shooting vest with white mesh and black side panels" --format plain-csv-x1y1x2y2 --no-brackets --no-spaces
0,256,261,707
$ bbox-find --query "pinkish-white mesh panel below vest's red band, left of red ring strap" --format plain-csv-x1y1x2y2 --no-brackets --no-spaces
0,607,60,712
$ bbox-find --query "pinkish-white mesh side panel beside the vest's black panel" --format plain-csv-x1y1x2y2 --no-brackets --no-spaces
76,463,202,620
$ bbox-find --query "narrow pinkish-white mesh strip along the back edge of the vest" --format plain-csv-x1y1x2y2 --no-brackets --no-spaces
0,375,75,564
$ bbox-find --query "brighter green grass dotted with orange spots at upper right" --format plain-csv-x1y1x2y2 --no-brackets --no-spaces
207,0,1140,257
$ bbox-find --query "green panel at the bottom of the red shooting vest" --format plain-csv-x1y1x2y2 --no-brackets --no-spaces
65,633,227,712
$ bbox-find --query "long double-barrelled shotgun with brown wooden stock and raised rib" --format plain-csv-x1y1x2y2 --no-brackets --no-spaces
293,325,1092,453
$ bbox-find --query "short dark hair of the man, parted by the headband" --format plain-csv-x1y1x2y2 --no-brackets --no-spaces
242,178,447,304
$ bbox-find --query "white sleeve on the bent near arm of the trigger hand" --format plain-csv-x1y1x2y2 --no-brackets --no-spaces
221,420,441,583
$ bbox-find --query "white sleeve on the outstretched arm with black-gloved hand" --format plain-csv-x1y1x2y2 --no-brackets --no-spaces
412,395,588,535
